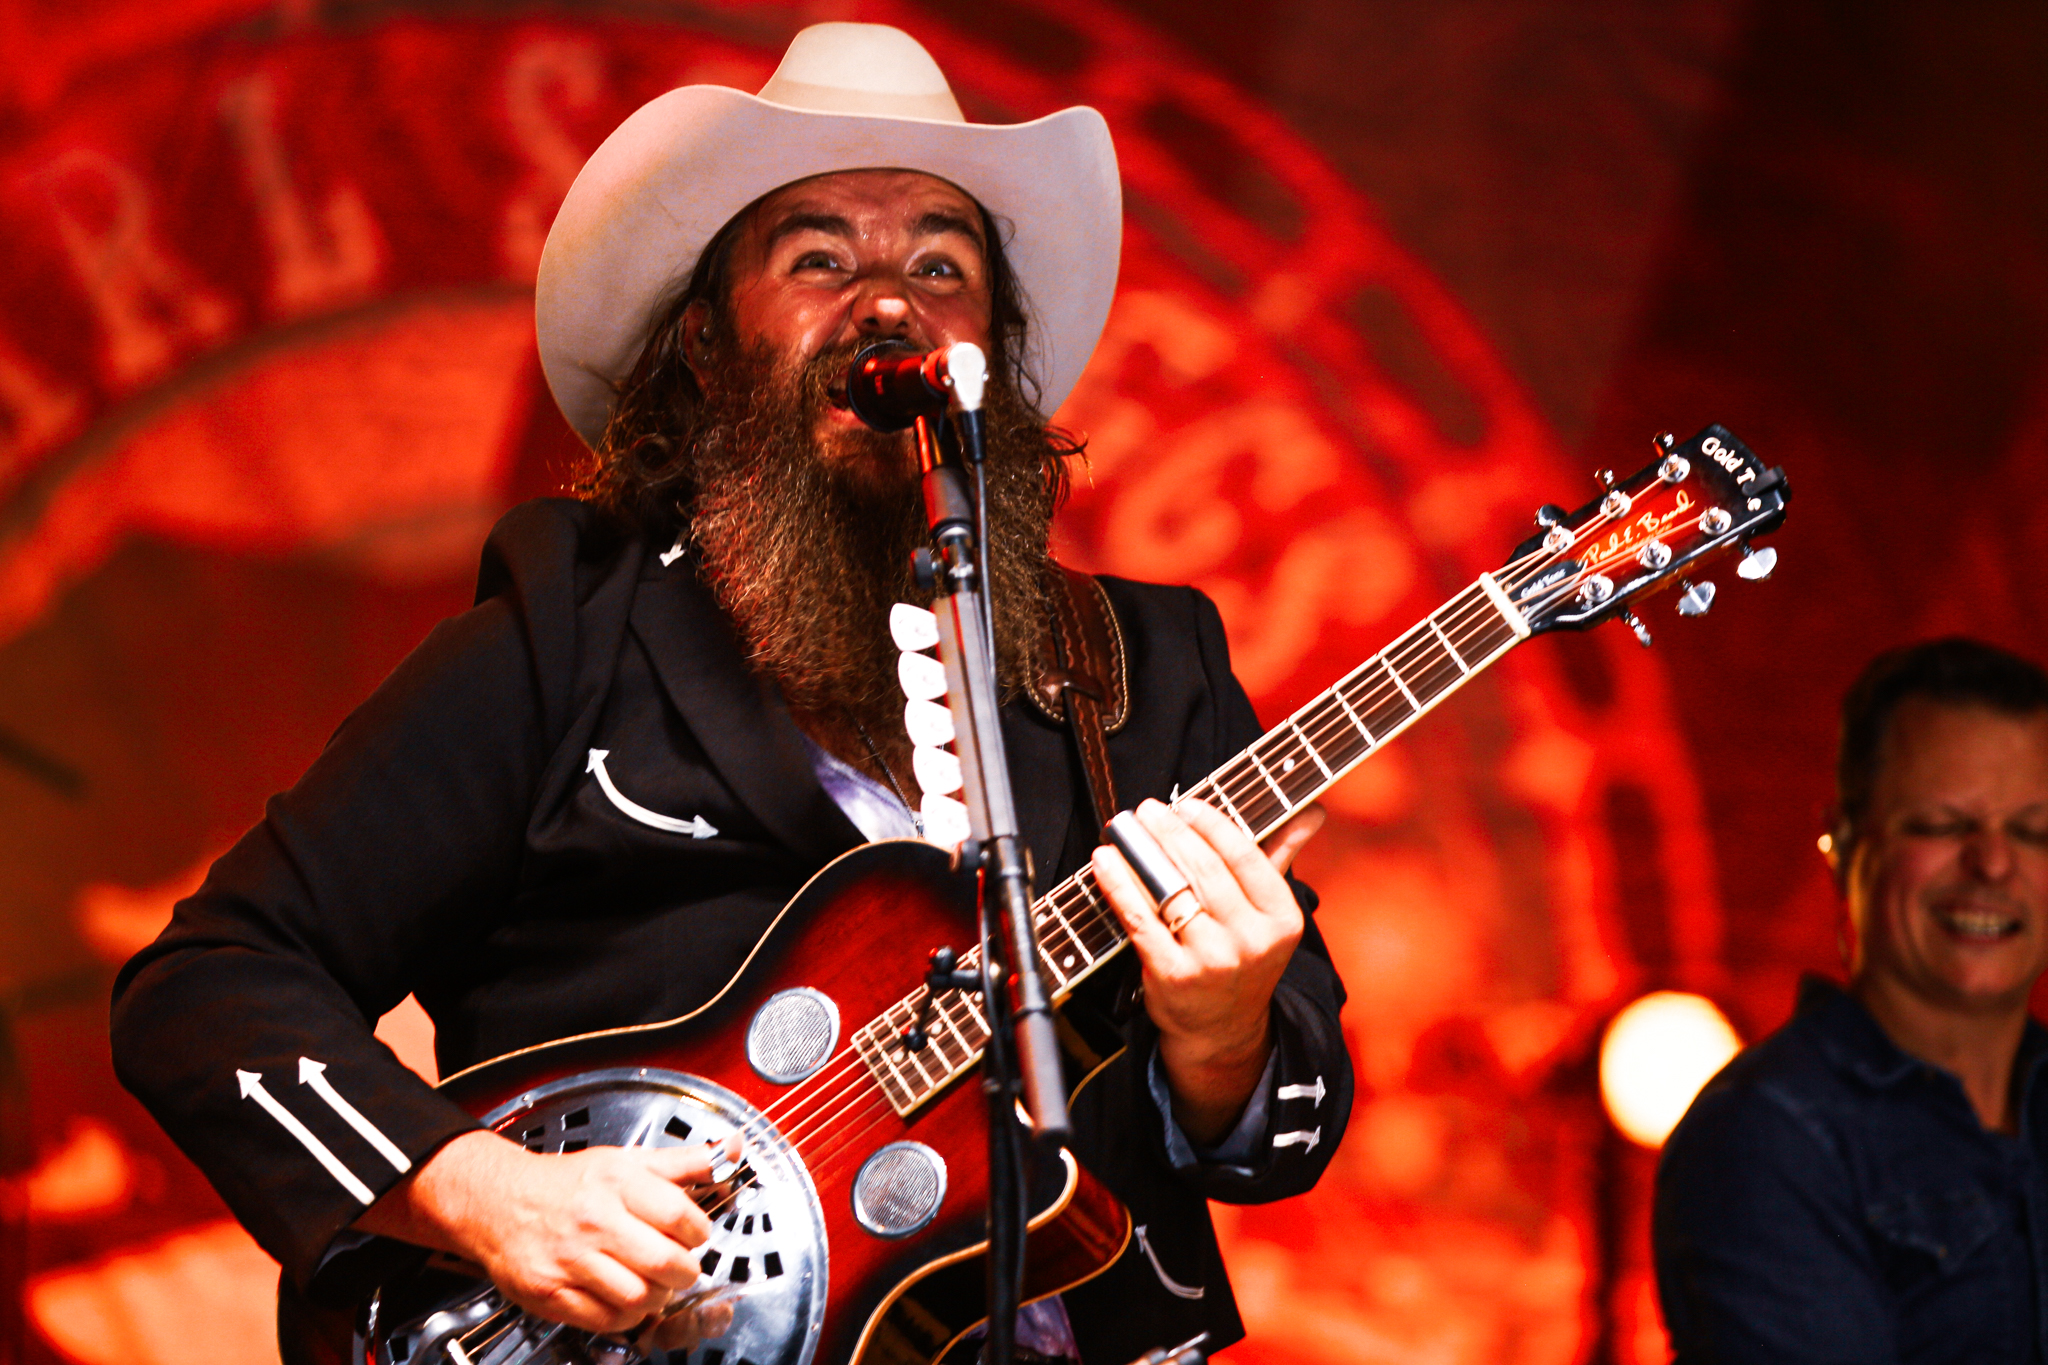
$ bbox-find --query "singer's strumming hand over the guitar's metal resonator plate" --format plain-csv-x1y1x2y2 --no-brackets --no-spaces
356,1132,739,1345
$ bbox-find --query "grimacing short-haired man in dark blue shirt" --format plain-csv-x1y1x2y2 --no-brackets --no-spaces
1653,639,2048,1365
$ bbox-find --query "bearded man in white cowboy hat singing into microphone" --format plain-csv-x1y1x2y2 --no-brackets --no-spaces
113,25,1352,1365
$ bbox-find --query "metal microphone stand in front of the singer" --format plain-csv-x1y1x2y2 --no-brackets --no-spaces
915,346,1073,1365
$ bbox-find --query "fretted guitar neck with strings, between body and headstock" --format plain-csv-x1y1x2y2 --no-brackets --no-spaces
852,573,1530,1113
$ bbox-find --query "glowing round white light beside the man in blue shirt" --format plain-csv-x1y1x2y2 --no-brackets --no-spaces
1599,990,1743,1148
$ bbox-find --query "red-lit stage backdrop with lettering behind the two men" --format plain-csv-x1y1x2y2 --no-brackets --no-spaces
0,0,2048,1365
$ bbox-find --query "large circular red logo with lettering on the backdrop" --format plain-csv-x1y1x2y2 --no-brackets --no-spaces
0,0,1720,1365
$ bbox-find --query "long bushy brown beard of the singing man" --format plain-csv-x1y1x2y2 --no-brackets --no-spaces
684,346,1053,749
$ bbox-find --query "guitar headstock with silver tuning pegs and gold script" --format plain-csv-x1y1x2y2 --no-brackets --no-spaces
1493,426,1792,645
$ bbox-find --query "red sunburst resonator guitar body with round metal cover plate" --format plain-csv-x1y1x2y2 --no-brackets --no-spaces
305,841,1130,1365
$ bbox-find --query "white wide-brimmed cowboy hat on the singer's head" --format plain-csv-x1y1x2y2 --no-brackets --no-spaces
535,23,1124,446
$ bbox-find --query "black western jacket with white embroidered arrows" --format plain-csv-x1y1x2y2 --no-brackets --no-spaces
113,499,1352,1363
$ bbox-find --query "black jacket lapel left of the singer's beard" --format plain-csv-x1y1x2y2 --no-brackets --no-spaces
633,559,862,862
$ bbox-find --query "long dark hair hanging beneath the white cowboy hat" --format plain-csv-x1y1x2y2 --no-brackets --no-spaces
571,185,1087,536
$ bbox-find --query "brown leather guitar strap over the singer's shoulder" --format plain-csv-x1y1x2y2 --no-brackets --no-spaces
1032,565,1130,829
